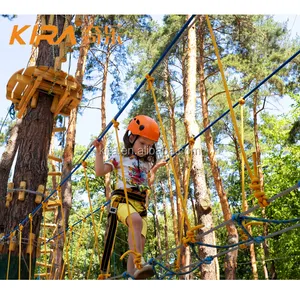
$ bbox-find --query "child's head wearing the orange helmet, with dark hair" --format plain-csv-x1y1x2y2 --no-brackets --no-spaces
123,115,160,164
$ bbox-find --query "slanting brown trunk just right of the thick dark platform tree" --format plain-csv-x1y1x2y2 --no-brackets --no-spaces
52,16,94,279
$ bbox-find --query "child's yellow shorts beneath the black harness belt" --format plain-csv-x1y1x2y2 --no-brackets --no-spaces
111,195,147,238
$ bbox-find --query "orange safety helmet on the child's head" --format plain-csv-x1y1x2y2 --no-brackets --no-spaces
127,115,160,142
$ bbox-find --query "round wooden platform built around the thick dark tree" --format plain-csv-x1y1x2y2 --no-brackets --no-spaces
6,66,82,118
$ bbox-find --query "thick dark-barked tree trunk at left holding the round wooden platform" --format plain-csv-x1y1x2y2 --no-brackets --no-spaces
0,15,65,279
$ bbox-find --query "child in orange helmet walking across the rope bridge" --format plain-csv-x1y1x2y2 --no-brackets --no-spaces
93,115,166,279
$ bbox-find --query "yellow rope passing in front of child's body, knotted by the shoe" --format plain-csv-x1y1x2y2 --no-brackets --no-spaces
112,119,141,269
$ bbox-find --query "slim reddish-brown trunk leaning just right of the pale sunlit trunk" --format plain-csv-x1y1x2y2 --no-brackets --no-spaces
198,16,238,279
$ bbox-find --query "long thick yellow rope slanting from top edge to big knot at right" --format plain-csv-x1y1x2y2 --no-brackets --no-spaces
205,15,269,207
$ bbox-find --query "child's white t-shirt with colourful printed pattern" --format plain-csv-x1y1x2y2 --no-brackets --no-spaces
105,154,151,189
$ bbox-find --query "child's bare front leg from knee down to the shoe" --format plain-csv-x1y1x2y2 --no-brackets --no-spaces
126,213,145,275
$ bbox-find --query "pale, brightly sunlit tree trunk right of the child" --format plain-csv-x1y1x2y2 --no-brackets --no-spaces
183,15,216,279
